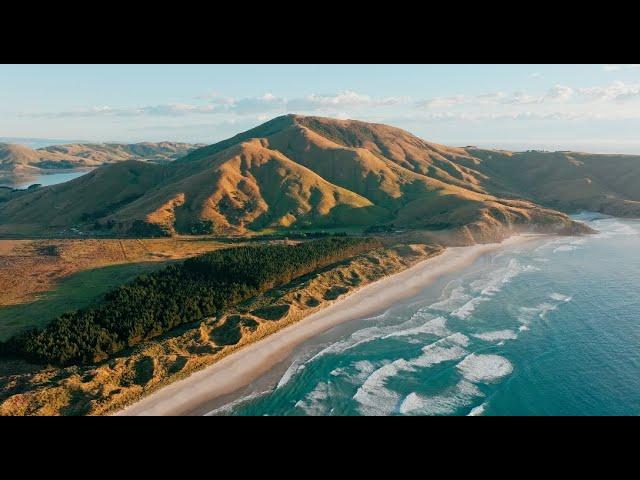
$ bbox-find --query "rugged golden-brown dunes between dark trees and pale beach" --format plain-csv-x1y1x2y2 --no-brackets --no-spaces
0,244,443,415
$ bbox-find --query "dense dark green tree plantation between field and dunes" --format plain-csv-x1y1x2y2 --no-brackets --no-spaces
0,237,381,365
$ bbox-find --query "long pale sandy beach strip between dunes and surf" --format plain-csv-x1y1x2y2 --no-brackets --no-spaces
115,235,540,416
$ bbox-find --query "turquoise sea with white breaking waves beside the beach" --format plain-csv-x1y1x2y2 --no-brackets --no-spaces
218,214,640,415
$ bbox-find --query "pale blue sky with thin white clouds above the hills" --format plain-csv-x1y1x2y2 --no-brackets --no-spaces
0,64,640,154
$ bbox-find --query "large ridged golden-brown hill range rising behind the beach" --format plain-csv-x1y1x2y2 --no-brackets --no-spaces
0,115,640,241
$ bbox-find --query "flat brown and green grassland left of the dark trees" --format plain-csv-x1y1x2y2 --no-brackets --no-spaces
0,238,228,340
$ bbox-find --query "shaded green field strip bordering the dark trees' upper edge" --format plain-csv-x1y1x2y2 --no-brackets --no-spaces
0,262,167,341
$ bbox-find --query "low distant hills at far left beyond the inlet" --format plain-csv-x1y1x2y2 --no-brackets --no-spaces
0,142,202,174
